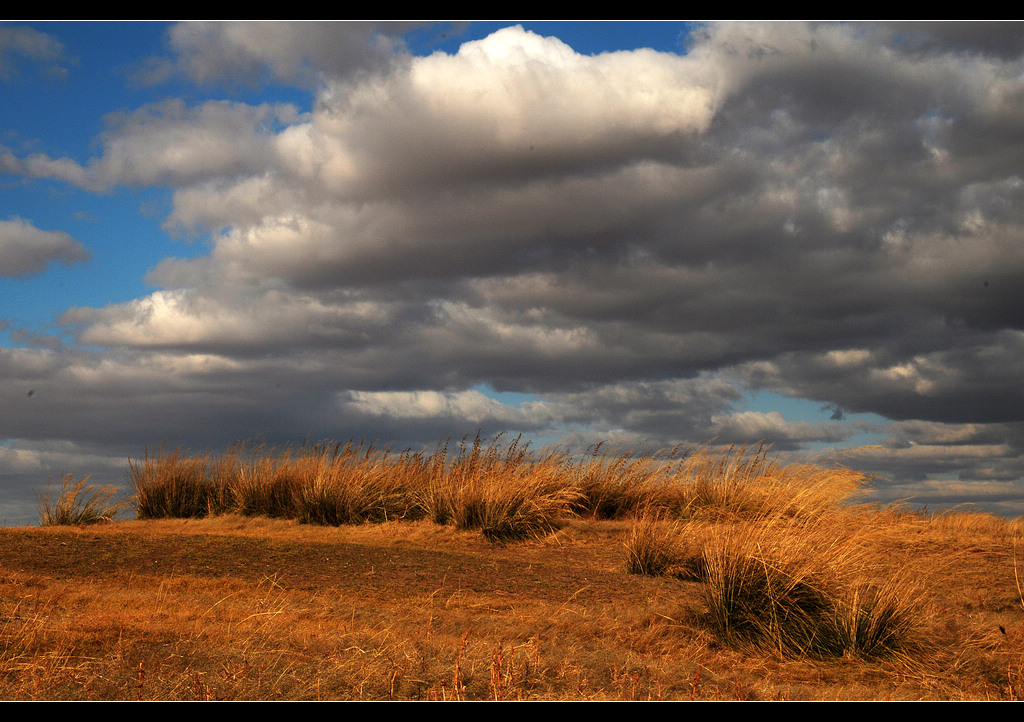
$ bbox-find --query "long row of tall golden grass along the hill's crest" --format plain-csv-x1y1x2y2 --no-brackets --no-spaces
129,434,864,541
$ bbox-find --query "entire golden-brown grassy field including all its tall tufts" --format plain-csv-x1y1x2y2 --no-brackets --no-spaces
0,439,1024,700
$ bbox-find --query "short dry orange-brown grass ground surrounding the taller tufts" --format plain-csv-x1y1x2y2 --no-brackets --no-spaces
0,510,1024,699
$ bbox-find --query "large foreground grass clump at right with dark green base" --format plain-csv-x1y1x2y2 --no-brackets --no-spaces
703,521,920,657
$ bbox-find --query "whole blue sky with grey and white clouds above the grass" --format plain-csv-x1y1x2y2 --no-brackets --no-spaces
0,22,1024,524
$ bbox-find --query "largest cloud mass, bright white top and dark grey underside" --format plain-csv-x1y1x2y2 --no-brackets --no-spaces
48,24,1024,422
